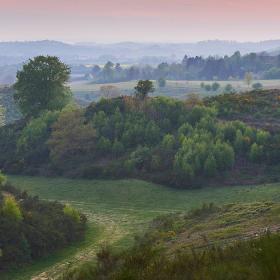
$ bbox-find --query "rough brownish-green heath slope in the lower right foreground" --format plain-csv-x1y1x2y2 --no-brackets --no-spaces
59,197,280,280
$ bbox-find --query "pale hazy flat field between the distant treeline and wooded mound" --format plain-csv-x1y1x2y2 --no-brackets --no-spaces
71,80,280,102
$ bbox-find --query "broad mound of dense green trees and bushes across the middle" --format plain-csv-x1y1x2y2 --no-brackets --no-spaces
0,95,280,187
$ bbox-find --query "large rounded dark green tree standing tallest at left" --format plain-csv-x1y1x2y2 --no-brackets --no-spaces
14,56,71,116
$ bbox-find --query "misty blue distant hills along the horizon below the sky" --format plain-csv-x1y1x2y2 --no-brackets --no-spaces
0,40,280,65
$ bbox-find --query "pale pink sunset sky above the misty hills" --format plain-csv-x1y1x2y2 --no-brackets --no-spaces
0,0,280,43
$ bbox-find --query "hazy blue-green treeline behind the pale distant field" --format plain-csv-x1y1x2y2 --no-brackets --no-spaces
84,52,280,83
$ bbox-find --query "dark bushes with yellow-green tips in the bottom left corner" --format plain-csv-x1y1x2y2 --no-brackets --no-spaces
0,174,86,272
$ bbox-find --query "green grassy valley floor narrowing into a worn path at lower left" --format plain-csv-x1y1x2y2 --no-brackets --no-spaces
4,176,280,280
